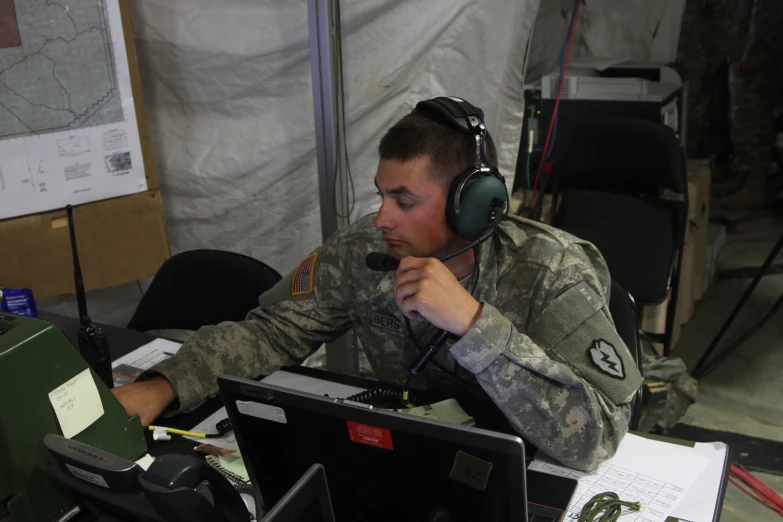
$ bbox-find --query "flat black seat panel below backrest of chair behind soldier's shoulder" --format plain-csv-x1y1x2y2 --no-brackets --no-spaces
554,189,687,304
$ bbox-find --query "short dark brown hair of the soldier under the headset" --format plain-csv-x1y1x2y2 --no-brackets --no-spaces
378,109,498,183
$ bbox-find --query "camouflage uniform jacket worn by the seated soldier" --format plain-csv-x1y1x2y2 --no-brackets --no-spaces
147,216,642,469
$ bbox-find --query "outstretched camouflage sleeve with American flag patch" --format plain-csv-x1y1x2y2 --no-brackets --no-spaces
139,227,350,413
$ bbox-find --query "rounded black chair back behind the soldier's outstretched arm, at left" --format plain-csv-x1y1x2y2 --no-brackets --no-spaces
128,250,282,331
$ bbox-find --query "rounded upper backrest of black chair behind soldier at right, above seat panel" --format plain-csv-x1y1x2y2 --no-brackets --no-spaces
556,117,688,196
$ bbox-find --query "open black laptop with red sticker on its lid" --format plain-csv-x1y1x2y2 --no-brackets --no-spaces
218,376,576,522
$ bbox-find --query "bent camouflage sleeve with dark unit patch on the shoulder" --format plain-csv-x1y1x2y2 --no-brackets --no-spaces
451,242,642,470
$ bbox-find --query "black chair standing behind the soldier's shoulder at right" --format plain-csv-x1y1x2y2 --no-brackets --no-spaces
553,118,688,355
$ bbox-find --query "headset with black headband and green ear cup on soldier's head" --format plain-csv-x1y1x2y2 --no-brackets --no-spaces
416,96,509,241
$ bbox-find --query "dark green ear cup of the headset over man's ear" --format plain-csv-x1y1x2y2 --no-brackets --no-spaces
453,174,508,241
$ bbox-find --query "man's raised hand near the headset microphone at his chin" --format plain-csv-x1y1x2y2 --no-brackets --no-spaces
394,257,481,337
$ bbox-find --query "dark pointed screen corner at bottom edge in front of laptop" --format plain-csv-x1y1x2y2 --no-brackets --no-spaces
260,464,335,522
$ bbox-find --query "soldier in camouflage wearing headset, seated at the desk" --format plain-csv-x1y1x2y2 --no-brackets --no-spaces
114,98,642,470
